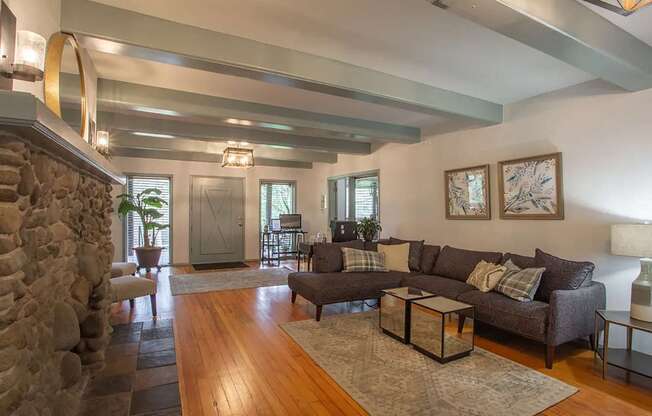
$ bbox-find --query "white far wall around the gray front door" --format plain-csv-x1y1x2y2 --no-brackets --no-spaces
111,157,319,264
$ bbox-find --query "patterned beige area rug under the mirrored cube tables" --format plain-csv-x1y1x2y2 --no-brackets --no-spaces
281,311,577,416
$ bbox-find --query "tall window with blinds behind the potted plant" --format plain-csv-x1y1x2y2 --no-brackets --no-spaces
125,176,172,265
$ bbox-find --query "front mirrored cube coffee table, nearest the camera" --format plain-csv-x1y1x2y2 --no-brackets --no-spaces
410,296,475,364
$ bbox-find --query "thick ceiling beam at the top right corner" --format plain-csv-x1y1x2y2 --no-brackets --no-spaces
442,0,652,91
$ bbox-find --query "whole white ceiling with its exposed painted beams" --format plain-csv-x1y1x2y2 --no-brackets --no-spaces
61,0,652,168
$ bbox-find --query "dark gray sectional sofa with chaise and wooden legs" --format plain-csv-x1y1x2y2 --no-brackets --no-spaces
288,238,606,368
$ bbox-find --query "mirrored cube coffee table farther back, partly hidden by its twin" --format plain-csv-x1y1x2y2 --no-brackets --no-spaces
379,287,435,344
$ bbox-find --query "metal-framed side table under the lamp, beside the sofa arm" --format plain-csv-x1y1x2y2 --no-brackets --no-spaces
594,310,652,378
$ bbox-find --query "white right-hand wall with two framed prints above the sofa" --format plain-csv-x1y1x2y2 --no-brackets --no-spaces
311,81,652,318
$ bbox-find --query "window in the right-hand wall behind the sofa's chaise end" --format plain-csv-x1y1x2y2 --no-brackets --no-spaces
328,172,380,221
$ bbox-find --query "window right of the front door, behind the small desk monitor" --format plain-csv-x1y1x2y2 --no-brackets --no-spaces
260,181,296,252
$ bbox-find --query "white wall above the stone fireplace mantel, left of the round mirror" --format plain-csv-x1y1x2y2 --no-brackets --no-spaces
5,0,61,100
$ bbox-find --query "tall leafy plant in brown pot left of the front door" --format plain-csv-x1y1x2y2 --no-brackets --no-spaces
118,188,170,271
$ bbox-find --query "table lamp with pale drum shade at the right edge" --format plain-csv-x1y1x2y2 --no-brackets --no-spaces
611,224,652,322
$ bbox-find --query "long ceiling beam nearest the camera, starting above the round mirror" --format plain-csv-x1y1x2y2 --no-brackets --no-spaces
61,0,503,125
